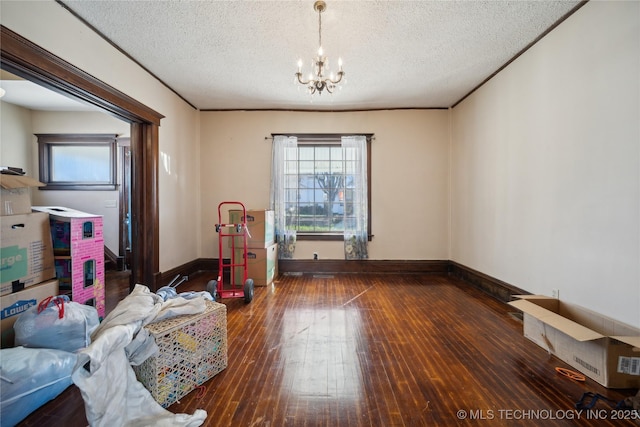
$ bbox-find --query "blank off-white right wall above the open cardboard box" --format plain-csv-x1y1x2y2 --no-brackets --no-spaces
451,1,640,326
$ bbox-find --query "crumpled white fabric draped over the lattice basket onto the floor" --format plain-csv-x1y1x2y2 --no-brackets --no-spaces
71,285,207,427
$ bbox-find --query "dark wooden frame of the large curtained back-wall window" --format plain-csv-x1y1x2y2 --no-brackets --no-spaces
271,133,374,241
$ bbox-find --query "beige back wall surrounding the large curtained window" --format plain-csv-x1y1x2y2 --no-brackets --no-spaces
200,110,449,260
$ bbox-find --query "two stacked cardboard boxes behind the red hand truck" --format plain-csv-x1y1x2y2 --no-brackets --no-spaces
229,209,278,286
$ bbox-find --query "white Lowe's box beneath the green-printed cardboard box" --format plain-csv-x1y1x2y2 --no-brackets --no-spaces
0,279,58,348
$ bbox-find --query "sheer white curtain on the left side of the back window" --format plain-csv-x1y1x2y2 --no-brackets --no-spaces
270,135,298,258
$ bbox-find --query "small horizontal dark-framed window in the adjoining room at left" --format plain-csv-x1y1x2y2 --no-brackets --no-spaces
36,134,117,190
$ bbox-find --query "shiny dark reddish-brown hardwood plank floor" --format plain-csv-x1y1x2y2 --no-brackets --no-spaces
21,274,637,427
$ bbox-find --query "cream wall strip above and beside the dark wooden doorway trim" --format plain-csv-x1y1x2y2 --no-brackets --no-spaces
0,0,200,271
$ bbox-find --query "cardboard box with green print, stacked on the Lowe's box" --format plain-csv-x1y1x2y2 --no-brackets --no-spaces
0,212,56,295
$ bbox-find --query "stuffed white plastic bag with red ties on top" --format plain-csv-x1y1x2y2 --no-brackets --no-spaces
13,295,100,353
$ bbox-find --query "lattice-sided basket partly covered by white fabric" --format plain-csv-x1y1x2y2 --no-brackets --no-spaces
133,301,227,408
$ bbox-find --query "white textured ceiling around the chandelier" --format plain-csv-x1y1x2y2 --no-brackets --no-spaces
59,0,580,110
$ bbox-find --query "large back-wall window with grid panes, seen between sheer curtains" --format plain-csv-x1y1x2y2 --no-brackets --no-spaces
274,135,371,240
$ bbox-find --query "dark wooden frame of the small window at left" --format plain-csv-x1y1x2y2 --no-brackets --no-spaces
35,133,118,191
